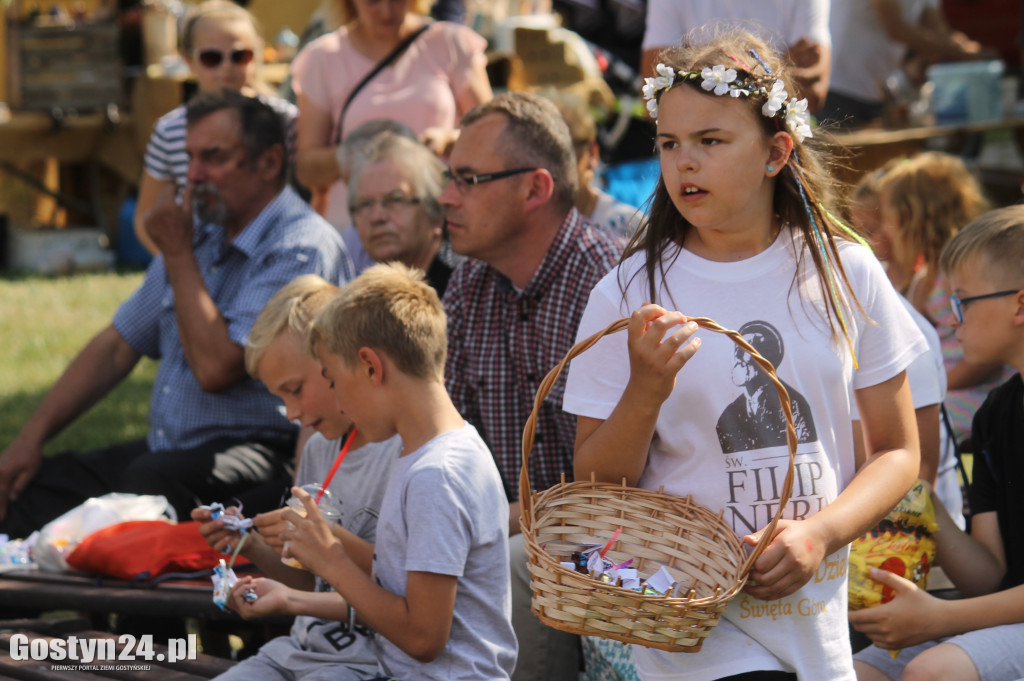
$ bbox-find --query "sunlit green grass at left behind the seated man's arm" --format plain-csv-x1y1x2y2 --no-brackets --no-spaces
0,272,157,454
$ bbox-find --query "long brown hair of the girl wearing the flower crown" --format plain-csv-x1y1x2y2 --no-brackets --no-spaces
620,29,860,338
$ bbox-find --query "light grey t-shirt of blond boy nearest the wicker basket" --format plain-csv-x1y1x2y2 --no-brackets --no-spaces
374,424,517,681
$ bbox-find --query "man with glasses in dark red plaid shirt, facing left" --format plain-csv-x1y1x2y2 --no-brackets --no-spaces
440,92,622,681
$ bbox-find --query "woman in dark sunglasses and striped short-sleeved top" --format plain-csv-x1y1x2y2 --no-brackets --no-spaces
134,0,299,254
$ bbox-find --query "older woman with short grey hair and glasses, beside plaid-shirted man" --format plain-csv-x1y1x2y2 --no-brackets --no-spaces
348,132,455,296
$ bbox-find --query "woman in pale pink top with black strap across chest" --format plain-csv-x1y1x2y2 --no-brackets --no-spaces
292,0,492,268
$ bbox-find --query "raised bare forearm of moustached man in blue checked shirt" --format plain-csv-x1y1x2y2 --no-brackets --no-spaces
145,187,246,392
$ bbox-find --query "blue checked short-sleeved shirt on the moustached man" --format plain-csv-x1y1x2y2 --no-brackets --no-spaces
114,187,352,452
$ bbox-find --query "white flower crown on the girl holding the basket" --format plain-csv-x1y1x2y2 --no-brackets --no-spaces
643,63,814,142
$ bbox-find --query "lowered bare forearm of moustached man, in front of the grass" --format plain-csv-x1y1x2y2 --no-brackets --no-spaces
0,325,141,520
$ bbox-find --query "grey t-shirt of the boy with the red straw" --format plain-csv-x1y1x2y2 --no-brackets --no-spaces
286,433,401,673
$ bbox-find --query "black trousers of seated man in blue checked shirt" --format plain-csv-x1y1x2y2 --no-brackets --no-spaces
0,437,295,538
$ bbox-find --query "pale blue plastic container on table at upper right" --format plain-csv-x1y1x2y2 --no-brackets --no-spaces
926,59,1004,125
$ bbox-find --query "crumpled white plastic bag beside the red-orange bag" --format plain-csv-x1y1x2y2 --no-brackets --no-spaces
32,492,177,572
